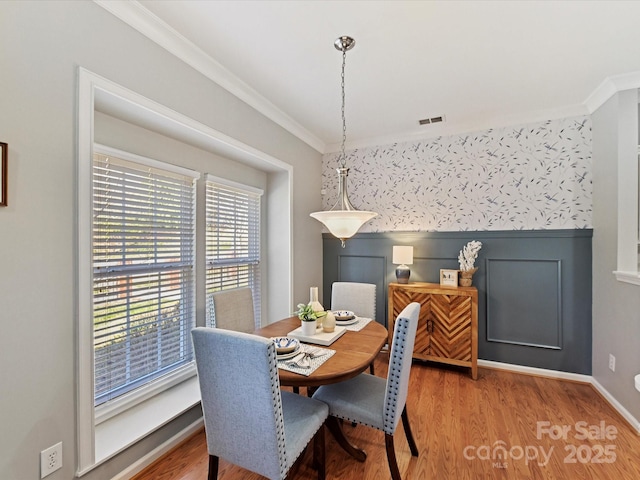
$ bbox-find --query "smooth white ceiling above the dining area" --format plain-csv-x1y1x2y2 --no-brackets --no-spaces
112,0,640,152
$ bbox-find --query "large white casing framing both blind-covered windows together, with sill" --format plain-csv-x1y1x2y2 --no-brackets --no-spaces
75,68,293,477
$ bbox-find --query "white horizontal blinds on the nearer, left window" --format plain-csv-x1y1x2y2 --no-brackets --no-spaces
92,147,198,405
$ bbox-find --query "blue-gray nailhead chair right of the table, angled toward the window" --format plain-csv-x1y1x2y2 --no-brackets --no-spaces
313,302,420,480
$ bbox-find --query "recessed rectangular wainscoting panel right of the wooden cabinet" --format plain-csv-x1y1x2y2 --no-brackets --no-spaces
485,258,562,350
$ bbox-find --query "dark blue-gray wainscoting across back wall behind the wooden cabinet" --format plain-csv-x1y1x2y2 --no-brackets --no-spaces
323,229,593,375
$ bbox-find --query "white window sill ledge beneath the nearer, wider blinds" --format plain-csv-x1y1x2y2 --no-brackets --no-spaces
94,376,200,466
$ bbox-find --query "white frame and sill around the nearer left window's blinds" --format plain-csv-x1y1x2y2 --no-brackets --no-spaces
77,141,200,470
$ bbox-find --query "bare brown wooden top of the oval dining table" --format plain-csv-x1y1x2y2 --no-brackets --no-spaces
254,317,387,387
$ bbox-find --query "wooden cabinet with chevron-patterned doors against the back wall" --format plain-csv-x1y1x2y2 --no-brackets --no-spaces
388,282,478,380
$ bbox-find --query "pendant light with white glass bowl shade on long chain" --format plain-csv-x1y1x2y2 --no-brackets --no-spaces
310,36,378,248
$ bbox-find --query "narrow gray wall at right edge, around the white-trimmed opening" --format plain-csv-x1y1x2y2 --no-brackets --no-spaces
593,91,640,419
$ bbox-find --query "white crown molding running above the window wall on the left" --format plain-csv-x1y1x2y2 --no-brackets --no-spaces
93,0,325,153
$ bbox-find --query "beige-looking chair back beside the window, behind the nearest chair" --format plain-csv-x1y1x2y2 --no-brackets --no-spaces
209,287,257,333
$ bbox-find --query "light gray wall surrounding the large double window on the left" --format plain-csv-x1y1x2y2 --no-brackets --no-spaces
0,1,322,480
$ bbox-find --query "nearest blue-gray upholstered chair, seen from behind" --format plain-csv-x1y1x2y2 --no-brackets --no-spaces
192,327,329,480
